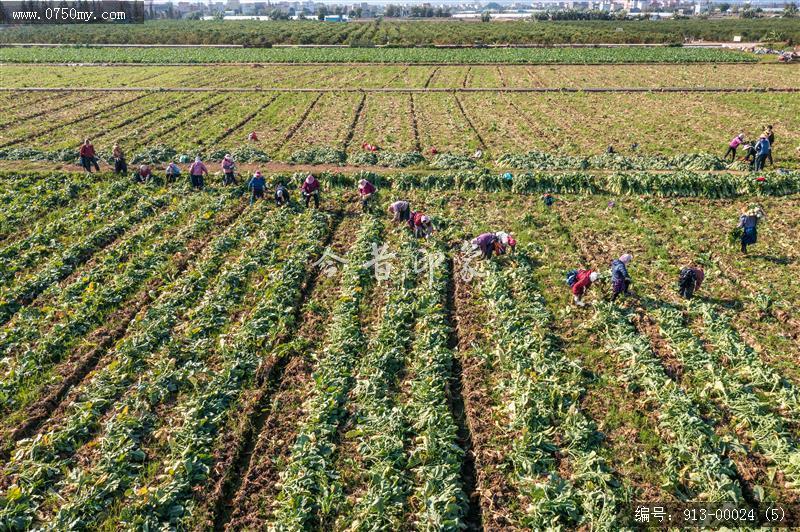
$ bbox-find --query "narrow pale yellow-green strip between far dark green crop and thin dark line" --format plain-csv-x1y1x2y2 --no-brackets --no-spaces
6,64,800,92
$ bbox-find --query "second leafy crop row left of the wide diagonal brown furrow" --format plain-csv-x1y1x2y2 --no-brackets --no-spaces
39,204,304,529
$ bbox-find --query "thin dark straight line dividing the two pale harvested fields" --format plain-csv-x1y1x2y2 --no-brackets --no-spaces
0,87,800,93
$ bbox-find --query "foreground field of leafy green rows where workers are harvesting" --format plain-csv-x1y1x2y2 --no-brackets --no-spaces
0,173,800,530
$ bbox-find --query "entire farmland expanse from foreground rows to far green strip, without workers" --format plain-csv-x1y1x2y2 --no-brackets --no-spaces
0,38,800,532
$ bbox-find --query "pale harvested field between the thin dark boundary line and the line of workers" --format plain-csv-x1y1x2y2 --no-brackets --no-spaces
0,86,800,165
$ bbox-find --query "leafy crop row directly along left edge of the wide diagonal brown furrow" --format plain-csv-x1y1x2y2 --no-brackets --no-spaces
121,207,329,529
